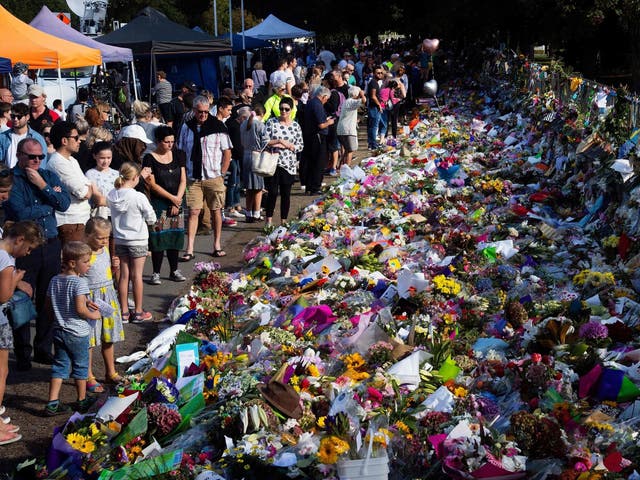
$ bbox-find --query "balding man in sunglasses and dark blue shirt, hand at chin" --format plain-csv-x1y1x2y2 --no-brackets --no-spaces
4,137,70,371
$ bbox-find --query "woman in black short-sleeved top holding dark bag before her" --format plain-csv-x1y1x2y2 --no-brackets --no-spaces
142,125,187,285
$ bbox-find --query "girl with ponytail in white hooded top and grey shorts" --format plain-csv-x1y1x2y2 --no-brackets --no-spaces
107,162,156,323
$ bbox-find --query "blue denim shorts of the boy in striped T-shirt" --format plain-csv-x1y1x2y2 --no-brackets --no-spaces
51,328,89,380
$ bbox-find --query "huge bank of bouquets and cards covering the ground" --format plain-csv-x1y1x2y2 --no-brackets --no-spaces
23,60,640,480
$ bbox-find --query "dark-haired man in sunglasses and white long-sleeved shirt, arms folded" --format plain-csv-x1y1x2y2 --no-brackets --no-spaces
47,122,107,245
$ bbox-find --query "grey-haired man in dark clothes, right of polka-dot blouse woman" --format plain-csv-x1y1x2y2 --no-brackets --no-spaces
303,87,335,195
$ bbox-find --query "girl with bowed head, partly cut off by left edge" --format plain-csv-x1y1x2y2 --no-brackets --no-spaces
0,221,44,445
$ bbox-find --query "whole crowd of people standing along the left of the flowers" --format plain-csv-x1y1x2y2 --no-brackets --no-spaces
0,43,426,445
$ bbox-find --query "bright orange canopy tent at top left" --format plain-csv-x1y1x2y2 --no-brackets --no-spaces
0,5,102,69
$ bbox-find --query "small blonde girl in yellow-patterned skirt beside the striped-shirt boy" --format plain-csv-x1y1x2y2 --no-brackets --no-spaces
85,217,124,393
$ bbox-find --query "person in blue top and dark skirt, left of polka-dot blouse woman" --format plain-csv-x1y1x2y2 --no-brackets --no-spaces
240,104,266,223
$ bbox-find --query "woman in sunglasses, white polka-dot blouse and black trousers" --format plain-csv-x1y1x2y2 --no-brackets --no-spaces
264,97,303,226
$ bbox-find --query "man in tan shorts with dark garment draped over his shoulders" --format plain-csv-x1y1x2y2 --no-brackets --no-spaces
178,95,233,262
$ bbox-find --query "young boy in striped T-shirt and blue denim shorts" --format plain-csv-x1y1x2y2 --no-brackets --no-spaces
44,242,100,416
